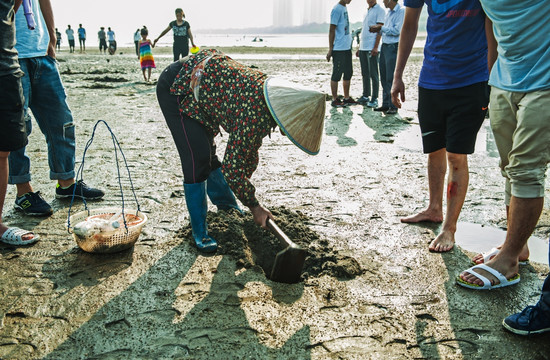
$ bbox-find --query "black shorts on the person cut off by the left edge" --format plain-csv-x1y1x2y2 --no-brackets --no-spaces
0,74,27,151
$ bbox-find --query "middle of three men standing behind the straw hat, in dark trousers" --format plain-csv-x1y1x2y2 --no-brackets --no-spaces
355,0,386,108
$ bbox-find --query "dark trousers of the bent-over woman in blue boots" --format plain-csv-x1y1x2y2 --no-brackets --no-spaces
157,62,221,184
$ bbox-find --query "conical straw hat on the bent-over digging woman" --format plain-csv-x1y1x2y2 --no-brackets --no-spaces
264,78,326,155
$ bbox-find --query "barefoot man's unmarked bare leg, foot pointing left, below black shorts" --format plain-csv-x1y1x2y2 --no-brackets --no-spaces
401,149,447,223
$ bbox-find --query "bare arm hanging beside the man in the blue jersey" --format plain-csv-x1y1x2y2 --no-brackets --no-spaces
391,7,422,108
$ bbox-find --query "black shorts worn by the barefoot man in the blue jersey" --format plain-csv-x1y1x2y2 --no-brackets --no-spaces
418,81,489,154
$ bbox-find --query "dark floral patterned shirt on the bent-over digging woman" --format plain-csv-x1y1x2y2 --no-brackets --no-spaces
170,49,277,207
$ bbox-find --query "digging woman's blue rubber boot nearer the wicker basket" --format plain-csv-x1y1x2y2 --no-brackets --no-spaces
187,181,218,252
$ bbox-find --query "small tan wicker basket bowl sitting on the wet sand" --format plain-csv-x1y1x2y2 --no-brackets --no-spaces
69,208,147,253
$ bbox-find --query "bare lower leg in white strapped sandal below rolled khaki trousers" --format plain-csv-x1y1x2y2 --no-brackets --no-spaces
460,196,544,285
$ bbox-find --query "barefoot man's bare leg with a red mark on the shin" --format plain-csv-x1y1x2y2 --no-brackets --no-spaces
430,153,469,252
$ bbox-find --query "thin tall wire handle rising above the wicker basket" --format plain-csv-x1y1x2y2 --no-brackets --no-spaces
67,120,141,233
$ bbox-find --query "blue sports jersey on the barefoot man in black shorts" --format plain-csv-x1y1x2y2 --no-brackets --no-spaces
405,0,489,90
